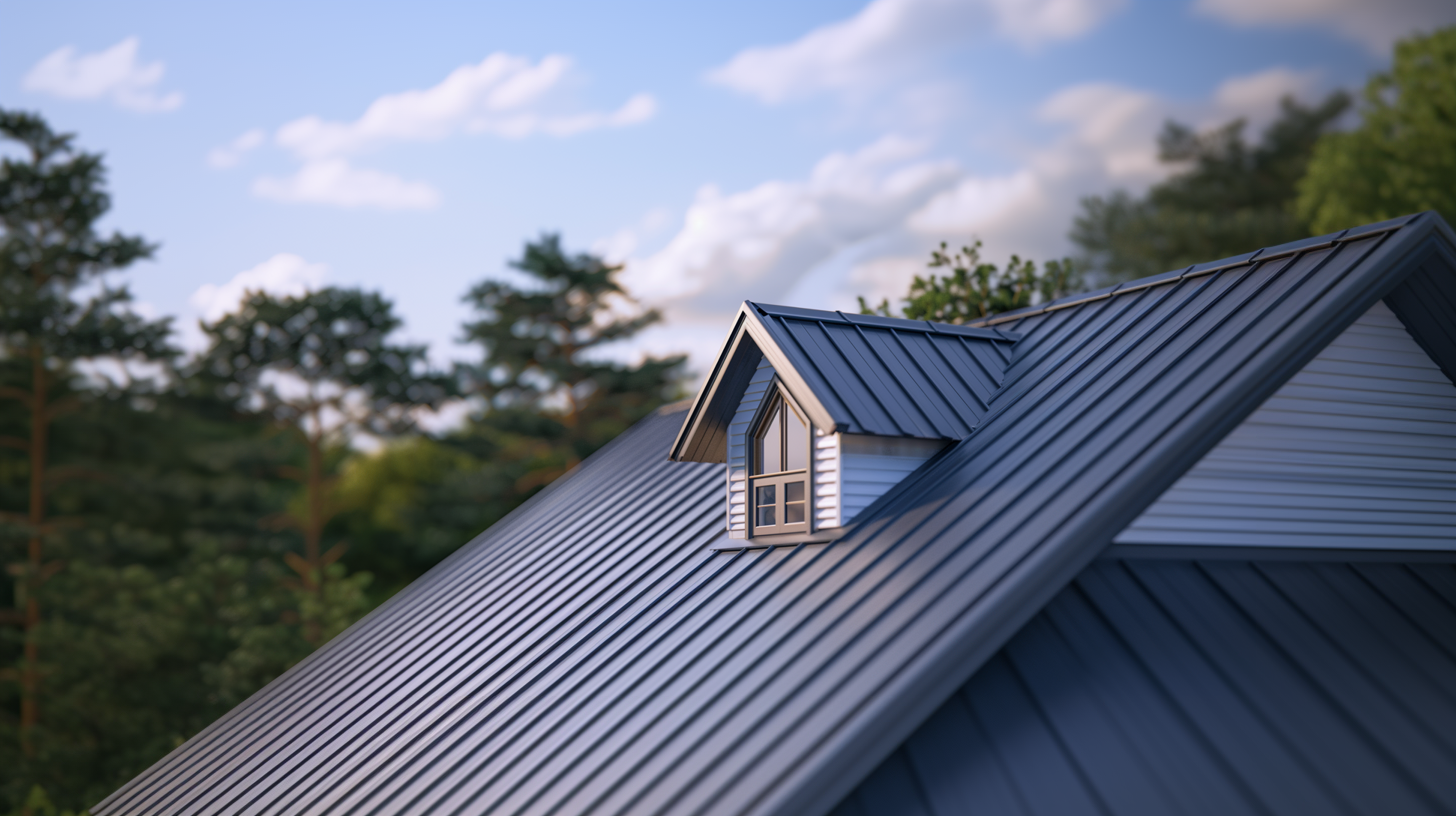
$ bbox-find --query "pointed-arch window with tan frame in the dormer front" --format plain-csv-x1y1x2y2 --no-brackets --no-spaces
748,393,810,535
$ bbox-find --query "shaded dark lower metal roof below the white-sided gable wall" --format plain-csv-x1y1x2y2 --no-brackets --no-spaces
834,561,1456,816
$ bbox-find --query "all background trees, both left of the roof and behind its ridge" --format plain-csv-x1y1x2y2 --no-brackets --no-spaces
0,22,1456,813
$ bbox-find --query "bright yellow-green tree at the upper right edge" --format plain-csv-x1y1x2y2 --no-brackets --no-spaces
1297,26,1456,233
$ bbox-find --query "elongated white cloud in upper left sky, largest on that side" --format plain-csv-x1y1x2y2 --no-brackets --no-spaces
275,52,657,159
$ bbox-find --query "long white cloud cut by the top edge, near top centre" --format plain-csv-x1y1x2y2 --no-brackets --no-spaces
708,0,1124,103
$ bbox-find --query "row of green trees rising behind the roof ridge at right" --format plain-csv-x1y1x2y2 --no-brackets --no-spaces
859,28,1456,323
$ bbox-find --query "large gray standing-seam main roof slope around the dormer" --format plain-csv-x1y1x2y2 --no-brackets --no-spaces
95,214,1456,816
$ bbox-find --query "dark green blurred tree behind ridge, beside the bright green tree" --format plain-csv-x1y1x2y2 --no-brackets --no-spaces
1070,92,1350,284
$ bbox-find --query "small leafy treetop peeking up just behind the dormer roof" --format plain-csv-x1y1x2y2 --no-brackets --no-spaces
859,240,1082,323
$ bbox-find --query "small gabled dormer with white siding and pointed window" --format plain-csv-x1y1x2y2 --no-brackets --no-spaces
670,302,1019,545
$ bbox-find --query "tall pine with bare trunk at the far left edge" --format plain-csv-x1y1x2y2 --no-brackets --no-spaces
0,111,173,755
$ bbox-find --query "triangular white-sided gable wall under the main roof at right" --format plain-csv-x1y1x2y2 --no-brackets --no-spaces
1115,303,1456,549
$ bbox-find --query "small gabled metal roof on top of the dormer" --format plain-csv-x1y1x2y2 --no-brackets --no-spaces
671,300,1021,462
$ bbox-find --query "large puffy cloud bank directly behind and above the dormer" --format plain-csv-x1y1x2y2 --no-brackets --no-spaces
620,67,1318,372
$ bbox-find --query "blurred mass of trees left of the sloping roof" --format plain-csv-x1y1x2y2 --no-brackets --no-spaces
0,111,683,815
